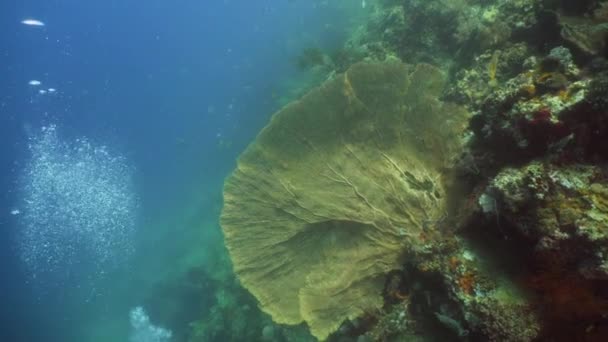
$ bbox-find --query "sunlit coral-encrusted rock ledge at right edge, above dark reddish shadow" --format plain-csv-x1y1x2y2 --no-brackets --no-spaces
486,162,608,279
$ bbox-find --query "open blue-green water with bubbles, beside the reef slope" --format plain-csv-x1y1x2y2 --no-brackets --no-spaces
0,0,361,341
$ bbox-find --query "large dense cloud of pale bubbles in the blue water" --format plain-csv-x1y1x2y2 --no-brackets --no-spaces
18,125,138,279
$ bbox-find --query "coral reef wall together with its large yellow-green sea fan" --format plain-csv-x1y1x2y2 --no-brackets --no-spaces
211,0,608,341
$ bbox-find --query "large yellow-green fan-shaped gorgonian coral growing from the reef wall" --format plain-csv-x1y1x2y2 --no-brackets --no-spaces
221,60,467,340
